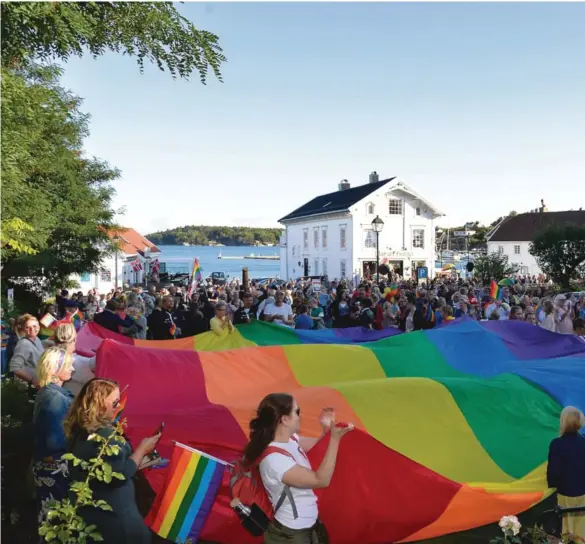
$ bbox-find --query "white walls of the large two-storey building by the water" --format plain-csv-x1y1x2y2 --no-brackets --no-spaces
280,179,443,280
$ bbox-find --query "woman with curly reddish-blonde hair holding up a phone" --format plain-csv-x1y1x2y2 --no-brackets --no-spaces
65,378,160,544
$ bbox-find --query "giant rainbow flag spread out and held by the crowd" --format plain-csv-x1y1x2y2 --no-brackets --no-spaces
96,319,585,544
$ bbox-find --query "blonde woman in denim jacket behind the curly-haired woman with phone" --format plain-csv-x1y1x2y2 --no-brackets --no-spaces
33,347,73,523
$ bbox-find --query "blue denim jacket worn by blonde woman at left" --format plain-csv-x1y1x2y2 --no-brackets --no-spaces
33,383,73,460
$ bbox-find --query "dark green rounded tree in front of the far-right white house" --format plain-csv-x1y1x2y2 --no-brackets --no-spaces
528,224,585,287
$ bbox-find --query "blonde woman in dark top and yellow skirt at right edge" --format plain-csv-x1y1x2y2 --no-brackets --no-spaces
547,406,585,540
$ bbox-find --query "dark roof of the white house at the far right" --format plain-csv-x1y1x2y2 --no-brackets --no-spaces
489,210,585,242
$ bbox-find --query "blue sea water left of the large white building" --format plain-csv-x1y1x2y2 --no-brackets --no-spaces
158,245,280,279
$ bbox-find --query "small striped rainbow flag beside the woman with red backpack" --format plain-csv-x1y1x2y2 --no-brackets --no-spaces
146,442,227,542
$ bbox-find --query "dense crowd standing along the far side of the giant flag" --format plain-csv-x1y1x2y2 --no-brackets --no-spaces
48,278,585,340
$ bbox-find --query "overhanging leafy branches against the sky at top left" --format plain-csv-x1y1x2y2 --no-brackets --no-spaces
1,2,226,83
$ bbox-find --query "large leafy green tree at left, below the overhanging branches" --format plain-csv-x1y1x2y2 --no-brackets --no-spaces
1,64,119,283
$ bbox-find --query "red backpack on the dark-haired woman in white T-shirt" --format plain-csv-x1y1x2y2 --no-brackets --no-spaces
230,436,298,520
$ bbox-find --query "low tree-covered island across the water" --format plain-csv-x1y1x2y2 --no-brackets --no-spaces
146,225,282,246
